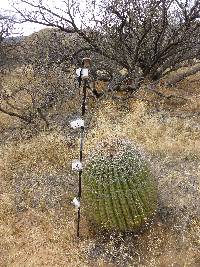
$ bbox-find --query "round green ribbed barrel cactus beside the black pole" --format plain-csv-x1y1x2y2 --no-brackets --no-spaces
83,140,157,232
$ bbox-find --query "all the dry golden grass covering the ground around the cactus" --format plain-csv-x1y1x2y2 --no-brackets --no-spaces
0,70,200,267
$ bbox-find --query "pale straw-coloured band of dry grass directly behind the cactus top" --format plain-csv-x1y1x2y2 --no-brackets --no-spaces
85,101,200,157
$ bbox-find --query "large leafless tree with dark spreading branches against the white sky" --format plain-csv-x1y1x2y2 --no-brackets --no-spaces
8,0,200,91
